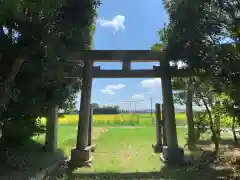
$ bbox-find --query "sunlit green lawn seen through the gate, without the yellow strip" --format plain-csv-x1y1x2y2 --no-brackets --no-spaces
35,125,186,173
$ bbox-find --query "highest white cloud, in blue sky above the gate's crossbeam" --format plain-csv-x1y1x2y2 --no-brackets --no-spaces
97,15,125,33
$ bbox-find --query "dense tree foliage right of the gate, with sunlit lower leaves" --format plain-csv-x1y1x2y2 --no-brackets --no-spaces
153,0,240,147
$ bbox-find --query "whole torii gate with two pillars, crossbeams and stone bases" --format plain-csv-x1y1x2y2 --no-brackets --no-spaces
63,50,195,166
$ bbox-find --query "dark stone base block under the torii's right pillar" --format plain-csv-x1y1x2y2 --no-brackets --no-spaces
161,146,185,165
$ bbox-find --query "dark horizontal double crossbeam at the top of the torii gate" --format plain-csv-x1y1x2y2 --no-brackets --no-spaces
65,50,200,78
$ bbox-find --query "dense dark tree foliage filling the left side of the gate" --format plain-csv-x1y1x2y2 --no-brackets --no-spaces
0,0,98,146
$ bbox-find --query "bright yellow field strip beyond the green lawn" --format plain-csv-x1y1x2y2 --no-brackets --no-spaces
42,113,186,126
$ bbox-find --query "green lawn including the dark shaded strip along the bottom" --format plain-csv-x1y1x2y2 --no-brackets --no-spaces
39,125,240,180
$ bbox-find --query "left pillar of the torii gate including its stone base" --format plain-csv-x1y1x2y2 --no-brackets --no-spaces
70,60,93,167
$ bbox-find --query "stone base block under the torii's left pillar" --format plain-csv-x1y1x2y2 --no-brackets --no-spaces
70,146,93,167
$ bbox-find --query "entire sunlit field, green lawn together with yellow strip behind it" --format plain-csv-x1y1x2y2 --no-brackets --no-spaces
34,113,186,177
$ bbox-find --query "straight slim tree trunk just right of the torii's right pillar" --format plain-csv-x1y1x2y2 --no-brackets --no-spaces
186,78,196,147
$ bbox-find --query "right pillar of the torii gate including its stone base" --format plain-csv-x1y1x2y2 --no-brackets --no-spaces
160,60,184,164
